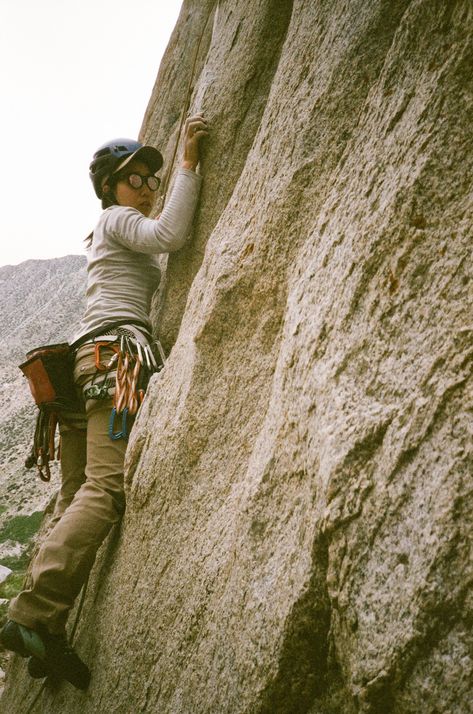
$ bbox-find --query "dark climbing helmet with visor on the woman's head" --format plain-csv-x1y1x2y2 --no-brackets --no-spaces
89,139,163,200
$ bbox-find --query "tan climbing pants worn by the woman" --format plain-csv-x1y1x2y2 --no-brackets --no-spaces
8,346,127,633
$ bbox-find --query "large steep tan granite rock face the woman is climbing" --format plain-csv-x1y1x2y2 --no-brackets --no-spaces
2,0,473,714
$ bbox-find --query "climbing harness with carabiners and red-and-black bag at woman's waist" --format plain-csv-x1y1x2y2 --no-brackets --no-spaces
19,328,165,481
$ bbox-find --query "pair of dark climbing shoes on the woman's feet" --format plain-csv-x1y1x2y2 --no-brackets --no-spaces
0,620,90,689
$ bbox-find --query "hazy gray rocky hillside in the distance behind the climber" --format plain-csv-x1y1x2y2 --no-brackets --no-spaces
0,255,86,564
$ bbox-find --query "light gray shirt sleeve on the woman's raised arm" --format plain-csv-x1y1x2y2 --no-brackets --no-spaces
106,168,202,254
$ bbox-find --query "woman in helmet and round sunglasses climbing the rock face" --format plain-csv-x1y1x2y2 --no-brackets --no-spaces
0,115,207,689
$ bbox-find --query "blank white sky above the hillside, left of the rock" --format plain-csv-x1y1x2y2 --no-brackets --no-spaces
0,0,182,266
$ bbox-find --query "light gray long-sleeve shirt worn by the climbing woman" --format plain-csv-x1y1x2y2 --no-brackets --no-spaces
73,169,202,341
